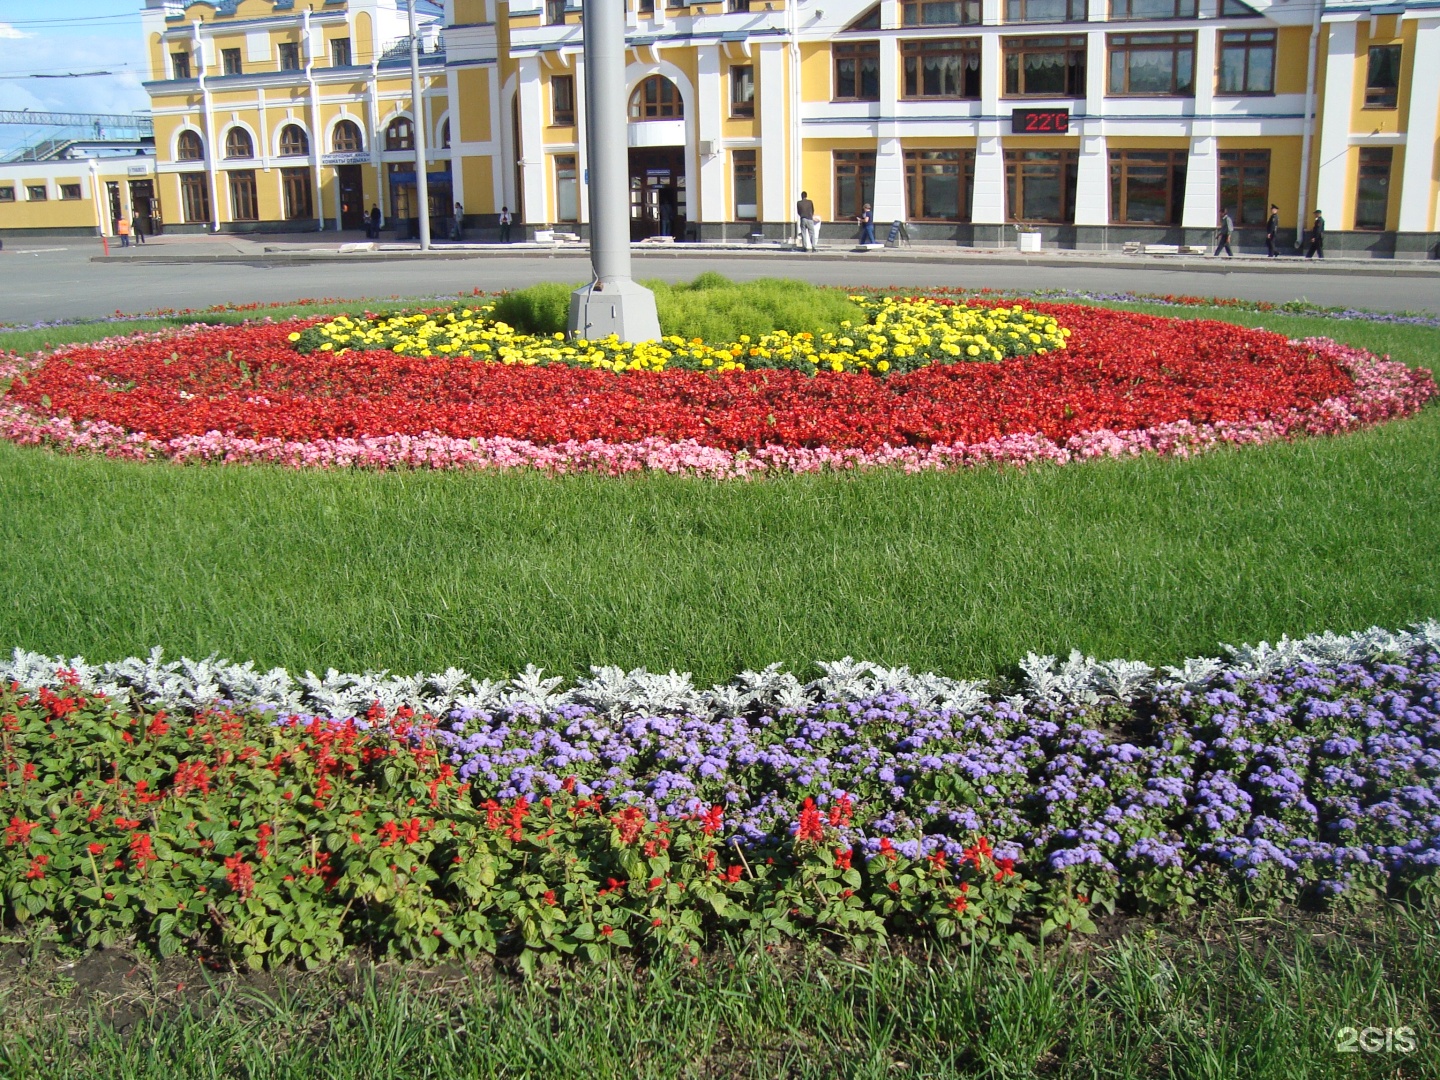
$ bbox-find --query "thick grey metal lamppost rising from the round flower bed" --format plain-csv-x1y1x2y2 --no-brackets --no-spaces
570,0,660,341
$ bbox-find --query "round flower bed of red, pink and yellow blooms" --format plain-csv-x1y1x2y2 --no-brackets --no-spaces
0,302,1434,475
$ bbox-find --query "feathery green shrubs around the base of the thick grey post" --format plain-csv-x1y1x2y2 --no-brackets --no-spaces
492,272,865,341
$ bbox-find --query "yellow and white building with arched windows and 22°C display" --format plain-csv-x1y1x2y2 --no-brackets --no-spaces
0,0,1440,258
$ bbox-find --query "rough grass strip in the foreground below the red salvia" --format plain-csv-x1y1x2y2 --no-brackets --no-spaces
0,909,1440,1080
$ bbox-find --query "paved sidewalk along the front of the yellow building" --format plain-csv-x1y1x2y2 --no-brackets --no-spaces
90,233,1440,281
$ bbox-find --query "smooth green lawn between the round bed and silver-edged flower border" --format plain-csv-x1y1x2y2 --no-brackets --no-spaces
0,305,1440,680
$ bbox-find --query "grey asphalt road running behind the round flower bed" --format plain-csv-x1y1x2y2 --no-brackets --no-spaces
0,238,1440,324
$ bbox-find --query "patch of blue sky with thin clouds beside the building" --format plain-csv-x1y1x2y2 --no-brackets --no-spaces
0,0,150,154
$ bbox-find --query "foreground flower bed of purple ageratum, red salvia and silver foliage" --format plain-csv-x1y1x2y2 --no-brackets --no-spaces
0,622,1440,965
